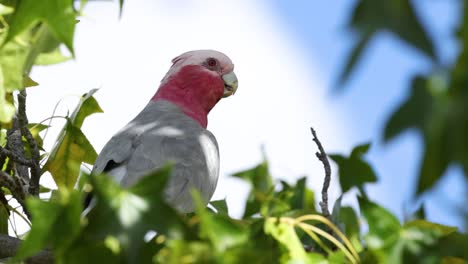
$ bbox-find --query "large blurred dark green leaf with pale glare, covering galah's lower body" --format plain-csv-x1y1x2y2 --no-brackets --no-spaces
64,167,184,263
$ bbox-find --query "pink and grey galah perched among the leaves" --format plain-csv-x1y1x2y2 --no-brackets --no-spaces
93,50,238,213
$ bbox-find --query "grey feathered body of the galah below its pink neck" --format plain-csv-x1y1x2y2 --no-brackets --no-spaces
93,101,219,212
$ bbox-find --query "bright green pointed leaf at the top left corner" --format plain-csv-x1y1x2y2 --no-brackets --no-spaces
4,0,76,54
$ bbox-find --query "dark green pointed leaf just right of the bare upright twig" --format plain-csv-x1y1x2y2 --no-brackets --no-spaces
329,144,377,193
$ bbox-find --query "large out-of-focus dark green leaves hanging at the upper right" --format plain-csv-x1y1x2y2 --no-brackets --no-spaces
339,0,468,195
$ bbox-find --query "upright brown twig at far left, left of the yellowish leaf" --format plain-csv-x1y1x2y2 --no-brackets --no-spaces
18,90,41,196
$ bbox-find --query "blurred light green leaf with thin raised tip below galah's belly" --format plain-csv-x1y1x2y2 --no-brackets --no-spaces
192,190,249,252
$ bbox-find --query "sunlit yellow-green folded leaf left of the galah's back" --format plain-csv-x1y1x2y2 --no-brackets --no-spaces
43,89,102,189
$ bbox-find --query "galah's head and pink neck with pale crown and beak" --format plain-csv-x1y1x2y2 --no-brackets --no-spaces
152,50,238,127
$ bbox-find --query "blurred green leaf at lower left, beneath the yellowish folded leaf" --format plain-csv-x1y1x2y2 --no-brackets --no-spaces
15,191,82,259
